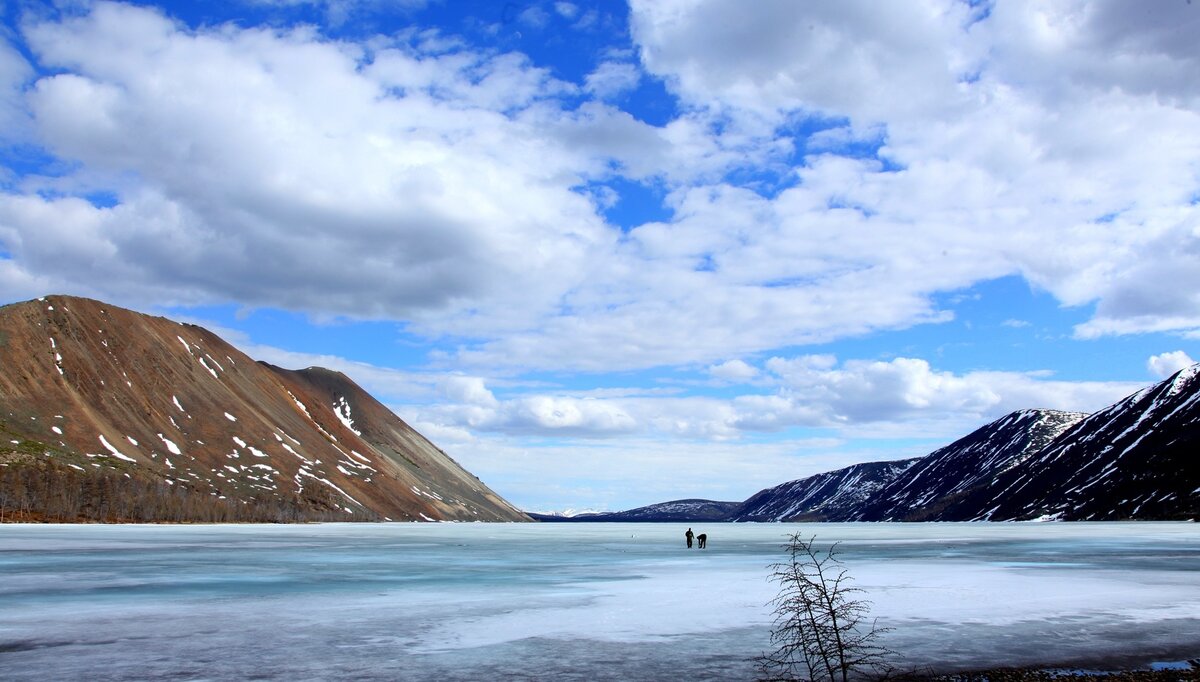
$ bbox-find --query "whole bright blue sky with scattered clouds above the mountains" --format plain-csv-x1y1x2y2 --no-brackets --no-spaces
0,0,1200,512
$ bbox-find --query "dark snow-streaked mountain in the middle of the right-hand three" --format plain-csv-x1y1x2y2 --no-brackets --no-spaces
836,409,1087,521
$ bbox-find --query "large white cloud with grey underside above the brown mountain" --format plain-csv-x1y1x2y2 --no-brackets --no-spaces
0,4,611,324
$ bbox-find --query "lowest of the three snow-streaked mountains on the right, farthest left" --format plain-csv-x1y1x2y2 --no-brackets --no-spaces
730,460,920,521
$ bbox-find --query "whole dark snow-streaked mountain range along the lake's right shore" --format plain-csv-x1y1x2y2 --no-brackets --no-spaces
552,364,1200,521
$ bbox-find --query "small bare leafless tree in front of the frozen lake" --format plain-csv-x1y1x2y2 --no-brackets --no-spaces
758,533,894,682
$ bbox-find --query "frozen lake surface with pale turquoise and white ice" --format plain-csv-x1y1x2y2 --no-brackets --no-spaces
0,524,1200,680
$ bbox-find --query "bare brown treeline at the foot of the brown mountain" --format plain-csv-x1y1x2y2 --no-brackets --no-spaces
0,461,380,524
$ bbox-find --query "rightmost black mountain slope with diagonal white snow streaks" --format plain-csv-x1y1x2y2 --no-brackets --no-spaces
938,364,1200,521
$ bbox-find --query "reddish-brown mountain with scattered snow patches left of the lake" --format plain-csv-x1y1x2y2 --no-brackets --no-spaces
0,297,528,521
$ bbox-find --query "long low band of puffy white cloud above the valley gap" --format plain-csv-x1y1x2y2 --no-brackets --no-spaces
413,354,1137,441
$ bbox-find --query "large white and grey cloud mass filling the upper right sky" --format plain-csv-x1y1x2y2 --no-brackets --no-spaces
631,0,1200,350
